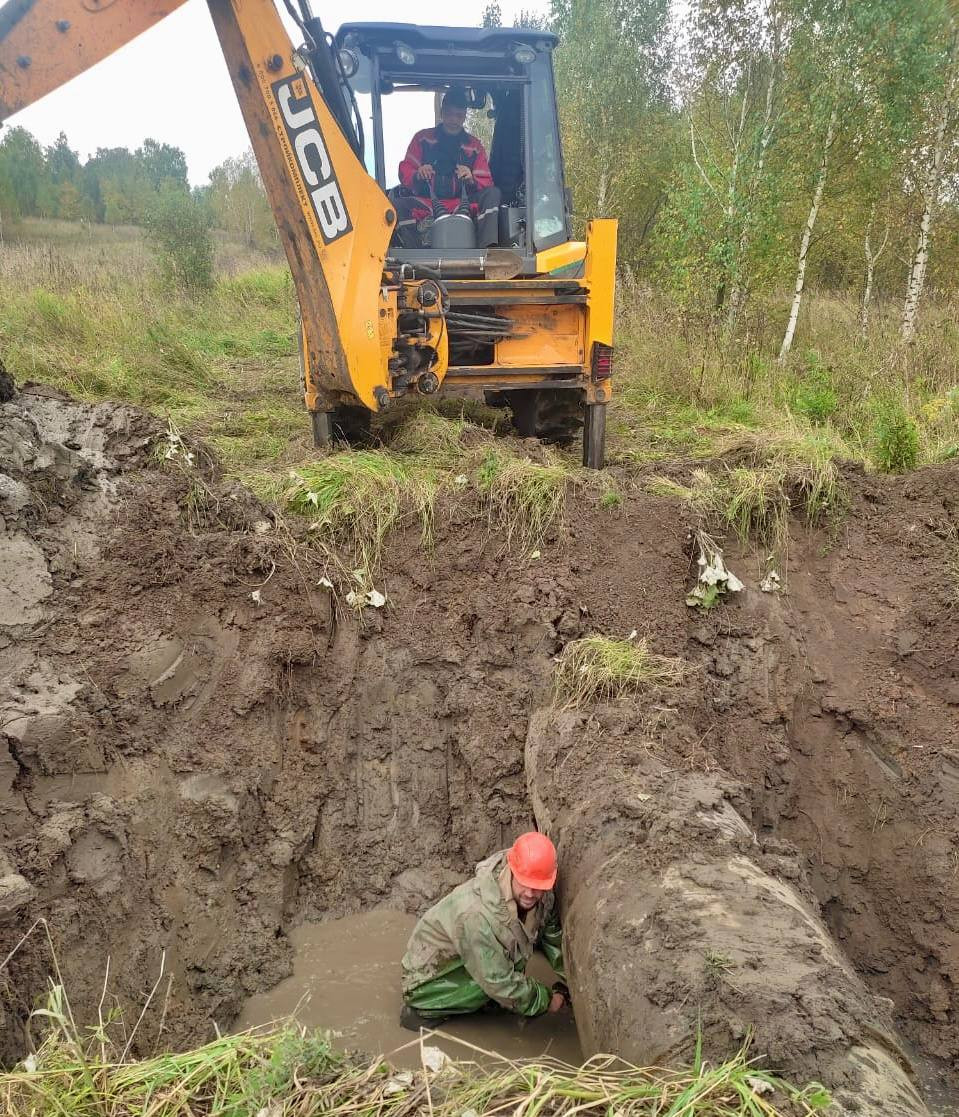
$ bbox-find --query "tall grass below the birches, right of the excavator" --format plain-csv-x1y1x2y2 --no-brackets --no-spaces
610,281,959,468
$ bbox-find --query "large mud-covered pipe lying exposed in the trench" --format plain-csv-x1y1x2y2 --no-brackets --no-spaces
526,710,927,1117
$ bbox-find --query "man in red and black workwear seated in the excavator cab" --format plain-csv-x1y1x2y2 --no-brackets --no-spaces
394,88,500,248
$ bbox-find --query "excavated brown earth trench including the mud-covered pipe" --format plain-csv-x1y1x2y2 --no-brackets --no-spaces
0,379,959,1114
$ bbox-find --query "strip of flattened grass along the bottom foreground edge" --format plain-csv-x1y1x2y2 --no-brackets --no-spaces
0,999,829,1117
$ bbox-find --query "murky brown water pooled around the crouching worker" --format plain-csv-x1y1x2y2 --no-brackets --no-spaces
237,908,581,1067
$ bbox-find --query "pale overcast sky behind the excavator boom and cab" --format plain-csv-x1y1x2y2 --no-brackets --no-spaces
7,0,545,185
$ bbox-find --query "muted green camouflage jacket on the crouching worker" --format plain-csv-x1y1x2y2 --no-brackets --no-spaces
403,851,563,1016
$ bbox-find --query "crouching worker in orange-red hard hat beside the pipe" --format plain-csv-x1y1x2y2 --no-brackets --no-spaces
400,831,569,1031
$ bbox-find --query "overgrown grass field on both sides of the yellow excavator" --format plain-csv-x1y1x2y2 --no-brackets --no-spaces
0,220,959,495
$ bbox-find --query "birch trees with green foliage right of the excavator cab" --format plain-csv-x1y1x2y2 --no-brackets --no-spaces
552,0,959,339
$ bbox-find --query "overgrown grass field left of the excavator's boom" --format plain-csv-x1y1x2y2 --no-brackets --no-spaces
0,220,310,484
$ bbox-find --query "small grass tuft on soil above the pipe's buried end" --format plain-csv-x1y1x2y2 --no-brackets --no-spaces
553,636,687,709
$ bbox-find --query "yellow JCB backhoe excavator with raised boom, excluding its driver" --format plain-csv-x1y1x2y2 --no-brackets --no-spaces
0,0,616,468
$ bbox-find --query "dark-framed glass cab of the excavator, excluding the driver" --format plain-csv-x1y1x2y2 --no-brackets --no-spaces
336,23,572,265
